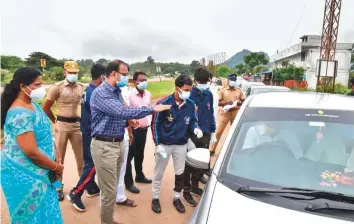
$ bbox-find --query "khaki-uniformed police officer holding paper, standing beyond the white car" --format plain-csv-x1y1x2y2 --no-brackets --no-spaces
210,74,246,155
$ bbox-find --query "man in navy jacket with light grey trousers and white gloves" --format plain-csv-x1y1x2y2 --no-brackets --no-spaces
151,75,203,213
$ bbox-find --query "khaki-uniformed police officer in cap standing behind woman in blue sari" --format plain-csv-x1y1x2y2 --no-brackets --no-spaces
43,61,84,201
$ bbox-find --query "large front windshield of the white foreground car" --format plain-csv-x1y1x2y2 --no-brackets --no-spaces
220,108,354,196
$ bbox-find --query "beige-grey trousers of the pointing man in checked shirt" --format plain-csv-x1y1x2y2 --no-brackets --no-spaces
91,138,124,224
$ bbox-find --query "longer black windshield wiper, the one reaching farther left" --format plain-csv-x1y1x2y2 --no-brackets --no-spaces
236,186,354,204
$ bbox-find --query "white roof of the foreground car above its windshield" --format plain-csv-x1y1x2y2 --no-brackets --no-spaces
247,92,354,111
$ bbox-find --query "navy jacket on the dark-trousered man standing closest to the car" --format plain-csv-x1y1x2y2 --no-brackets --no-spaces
190,87,216,134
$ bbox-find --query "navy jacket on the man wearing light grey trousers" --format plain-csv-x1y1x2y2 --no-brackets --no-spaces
151,94,198,145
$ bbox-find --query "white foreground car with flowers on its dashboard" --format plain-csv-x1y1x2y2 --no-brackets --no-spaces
187,92,354,224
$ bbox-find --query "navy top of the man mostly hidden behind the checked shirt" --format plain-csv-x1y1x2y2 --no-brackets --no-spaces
81,83,96,136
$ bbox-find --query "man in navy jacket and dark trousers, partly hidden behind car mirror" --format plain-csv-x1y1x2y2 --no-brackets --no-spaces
183,68,216,207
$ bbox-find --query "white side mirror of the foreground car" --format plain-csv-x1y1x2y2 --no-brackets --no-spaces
186,148,210,170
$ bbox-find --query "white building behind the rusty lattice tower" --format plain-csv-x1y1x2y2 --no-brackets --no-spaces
270,35,353,89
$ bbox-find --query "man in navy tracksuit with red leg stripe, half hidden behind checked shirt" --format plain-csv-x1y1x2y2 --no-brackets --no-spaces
67,64,106,212
